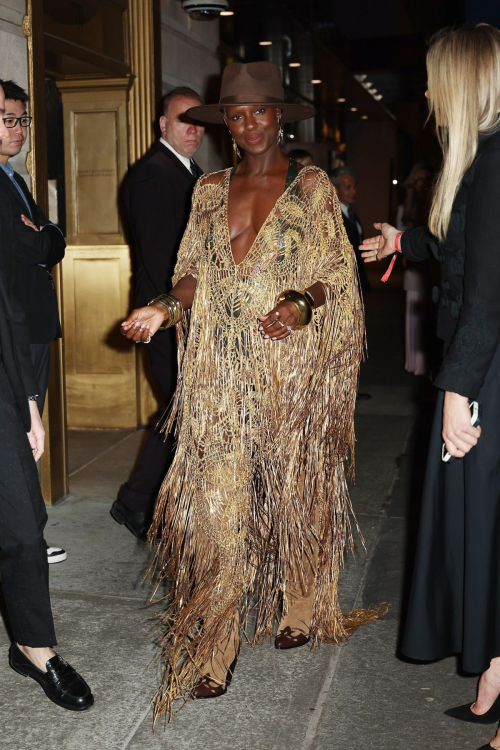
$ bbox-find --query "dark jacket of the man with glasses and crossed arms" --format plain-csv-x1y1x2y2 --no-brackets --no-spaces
0,169,66,344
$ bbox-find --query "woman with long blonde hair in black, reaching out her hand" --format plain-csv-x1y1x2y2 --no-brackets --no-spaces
362,24,500,750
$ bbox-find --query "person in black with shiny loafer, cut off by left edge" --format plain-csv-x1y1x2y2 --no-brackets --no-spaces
0,81,94,711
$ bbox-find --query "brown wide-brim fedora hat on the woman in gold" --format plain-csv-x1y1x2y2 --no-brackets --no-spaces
186,62,316,123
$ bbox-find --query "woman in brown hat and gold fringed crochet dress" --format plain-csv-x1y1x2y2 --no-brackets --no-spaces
123,63,381,717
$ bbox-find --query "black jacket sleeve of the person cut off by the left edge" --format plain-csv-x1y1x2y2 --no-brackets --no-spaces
0,182,38,432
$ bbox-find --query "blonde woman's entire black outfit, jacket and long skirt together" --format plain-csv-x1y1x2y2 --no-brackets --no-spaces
402,132,500,672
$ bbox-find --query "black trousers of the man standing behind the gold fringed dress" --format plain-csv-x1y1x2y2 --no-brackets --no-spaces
120,328,177,515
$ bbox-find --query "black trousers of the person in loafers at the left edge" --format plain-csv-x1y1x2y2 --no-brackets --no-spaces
0,361,56,648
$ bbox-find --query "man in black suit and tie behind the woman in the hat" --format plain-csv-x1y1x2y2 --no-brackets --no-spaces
111,87,205,539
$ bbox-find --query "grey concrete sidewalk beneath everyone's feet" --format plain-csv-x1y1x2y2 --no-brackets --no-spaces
0,279,493,750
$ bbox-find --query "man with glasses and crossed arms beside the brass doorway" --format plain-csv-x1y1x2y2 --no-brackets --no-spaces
0,81,67,563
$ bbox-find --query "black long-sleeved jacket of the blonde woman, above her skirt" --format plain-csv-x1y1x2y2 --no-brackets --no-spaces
401,132,500,399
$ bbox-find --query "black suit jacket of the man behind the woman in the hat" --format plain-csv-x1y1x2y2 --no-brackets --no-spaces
125,141,202,306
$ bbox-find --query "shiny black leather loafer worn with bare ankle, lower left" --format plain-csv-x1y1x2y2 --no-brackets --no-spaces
9,643,94,711
